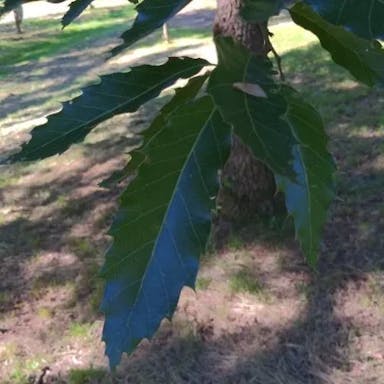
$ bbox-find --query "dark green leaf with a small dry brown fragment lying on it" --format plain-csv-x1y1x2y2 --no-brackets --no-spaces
208,38,295,174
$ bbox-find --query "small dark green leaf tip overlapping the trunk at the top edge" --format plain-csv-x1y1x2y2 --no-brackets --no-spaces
240,0,284,23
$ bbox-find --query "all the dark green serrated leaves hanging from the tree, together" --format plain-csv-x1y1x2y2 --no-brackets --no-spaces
0,0,384,366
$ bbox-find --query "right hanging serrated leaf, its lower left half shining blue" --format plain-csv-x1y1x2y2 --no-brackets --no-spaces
276,86,335,266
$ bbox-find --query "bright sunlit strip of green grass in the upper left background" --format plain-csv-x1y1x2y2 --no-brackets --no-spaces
0,7,211,77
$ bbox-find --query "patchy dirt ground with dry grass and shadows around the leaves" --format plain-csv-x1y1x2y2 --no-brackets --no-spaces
0,1,384,384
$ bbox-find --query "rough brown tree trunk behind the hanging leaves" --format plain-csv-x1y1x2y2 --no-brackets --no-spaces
213,0,276,222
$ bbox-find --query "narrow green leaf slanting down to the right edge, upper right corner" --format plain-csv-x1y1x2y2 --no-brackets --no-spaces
290,3,384,86
